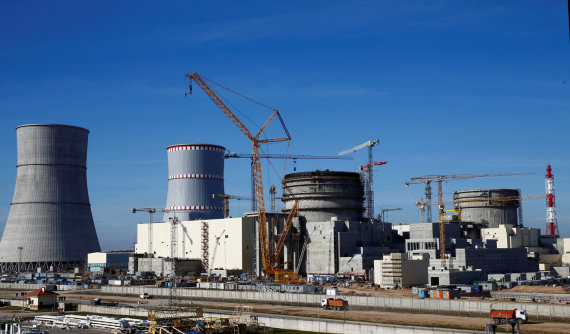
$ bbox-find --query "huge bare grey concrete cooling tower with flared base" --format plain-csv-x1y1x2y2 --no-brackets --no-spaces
0,124,101,270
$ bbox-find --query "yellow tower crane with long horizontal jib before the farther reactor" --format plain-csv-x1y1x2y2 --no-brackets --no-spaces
405,172,535,267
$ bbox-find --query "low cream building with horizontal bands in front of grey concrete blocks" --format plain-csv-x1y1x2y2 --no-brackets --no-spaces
374,253,429,289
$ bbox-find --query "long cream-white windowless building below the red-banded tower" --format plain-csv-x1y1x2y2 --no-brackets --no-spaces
135,218,253,271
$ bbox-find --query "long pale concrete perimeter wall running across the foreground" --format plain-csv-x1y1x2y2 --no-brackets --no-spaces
101,286,570,320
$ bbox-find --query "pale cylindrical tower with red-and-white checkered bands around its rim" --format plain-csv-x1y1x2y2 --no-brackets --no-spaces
164,144,225,221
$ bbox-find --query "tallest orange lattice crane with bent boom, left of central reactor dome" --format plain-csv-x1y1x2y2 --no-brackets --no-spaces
186,73,299,277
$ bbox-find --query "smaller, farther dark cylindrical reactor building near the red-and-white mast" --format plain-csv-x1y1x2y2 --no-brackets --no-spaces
453,189,520,227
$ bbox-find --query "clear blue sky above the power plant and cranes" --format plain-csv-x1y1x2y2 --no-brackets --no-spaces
0,0,570,250
